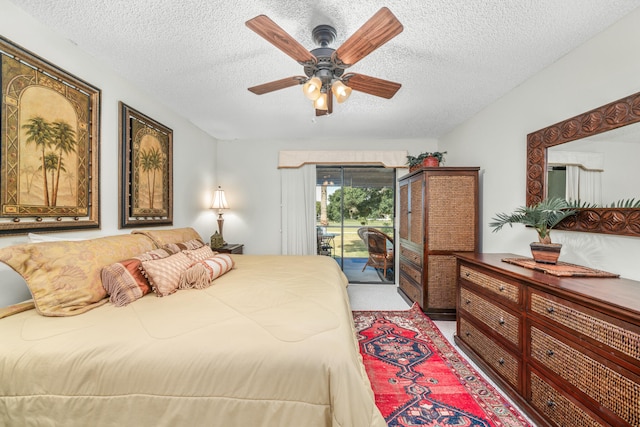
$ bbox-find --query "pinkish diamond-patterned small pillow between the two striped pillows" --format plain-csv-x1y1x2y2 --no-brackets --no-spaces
142,252,193,297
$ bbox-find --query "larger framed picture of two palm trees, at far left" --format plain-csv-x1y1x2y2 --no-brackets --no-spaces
0,36,101,235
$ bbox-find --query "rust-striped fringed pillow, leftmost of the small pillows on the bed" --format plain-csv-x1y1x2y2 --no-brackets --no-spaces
102,249,173,307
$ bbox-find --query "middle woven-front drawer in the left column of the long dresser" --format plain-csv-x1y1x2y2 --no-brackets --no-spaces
459,287,521,348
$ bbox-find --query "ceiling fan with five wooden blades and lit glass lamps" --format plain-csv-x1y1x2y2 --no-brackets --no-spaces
246,7,403,116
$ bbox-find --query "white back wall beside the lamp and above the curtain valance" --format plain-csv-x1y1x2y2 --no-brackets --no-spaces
218,139,438,254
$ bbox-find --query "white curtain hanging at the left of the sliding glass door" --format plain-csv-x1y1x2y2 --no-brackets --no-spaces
280,164,317,255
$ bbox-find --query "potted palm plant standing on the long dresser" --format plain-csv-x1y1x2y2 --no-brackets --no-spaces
489,198,576,264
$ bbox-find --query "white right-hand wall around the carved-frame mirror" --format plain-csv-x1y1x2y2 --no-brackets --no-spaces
440,10,640,280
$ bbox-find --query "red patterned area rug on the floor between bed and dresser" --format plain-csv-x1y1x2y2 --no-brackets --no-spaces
353,305,530,427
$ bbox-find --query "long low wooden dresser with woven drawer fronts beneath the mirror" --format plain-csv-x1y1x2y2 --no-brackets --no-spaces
455,254,640,427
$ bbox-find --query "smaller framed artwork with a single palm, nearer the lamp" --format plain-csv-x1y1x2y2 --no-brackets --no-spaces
119,102,173,228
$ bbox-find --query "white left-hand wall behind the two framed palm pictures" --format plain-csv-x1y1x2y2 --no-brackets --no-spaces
0,0,216,305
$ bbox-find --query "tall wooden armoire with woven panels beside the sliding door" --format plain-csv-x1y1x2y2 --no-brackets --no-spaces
398,167,480,320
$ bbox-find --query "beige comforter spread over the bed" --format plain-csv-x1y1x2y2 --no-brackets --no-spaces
0,255,386,427
